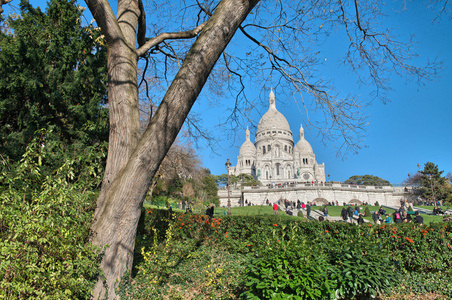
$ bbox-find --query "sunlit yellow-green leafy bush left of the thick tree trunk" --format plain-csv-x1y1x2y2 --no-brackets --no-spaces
0,130,102,299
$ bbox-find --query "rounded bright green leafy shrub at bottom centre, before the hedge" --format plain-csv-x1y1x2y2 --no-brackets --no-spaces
242,241,336,299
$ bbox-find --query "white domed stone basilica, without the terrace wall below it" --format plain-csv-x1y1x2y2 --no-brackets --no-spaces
229,90,325,185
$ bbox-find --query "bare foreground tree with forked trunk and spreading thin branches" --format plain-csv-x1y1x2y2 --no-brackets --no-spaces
2,0,444,299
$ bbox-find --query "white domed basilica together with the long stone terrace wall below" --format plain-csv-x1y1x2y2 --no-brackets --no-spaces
218,90,411,207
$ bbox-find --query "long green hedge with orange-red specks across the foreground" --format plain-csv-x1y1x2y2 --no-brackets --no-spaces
129,207,452,299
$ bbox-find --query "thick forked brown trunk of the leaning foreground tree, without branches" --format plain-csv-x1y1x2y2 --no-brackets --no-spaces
90,0,258,299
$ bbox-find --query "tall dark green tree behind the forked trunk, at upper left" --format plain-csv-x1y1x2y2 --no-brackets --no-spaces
0,0,108,161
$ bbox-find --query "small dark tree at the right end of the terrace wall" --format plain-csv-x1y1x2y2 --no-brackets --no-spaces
419,162,450,202
